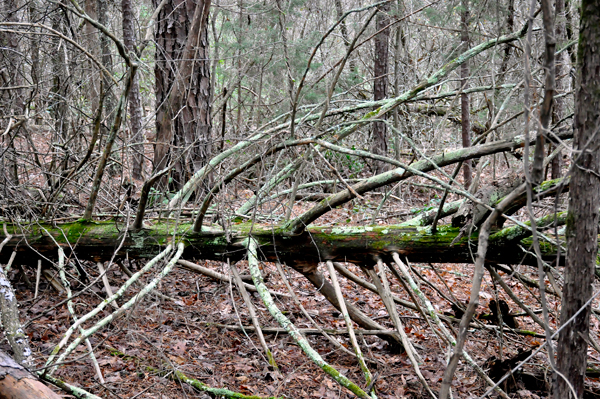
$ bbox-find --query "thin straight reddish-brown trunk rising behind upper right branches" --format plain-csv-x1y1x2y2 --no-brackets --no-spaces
460,0,472,190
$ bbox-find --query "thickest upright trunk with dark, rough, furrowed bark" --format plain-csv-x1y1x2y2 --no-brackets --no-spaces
154,0,211,189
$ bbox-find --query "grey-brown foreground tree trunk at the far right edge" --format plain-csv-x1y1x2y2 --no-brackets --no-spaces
554,0,600,399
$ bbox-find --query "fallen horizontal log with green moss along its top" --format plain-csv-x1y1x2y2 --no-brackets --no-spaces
0,221,564,274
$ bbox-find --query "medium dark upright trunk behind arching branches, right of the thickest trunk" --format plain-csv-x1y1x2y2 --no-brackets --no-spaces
371,3,390,173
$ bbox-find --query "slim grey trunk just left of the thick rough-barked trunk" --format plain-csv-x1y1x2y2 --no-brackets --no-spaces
121,0,144,180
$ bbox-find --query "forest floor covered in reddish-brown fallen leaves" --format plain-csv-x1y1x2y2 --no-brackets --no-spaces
11,188,600,399
